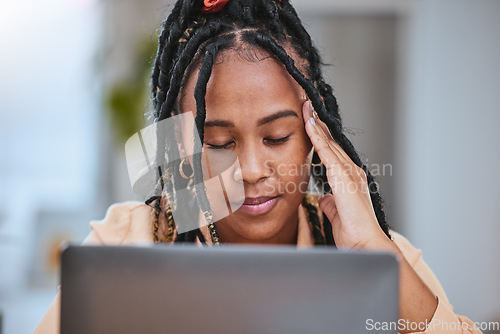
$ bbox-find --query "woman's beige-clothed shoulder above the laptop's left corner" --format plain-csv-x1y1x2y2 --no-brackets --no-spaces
87,201,153,245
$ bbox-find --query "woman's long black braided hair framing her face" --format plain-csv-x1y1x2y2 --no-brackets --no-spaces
146,0,390,245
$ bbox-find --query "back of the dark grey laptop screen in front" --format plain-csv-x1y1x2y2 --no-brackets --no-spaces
61,245,398,334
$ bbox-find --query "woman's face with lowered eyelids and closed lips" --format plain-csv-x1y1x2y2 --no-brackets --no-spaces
181,47,313,244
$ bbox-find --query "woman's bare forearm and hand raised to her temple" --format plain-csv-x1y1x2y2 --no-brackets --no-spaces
302,101,438,333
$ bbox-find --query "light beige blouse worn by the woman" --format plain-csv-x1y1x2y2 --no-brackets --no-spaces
34,202,481,334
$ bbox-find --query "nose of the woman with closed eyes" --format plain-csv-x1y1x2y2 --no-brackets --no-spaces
237,144,272,184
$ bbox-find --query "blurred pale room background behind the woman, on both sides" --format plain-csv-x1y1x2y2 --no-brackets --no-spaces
0,0,500,334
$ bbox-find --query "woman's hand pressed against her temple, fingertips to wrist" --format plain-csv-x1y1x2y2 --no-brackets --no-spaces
302,101,397,250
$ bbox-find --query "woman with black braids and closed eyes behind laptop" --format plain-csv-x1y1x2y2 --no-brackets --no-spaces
36,0,479,333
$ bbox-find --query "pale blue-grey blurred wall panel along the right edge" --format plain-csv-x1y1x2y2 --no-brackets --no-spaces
396,0,500,321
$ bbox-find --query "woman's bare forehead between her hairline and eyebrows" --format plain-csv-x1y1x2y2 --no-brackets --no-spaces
181,50,305,119
